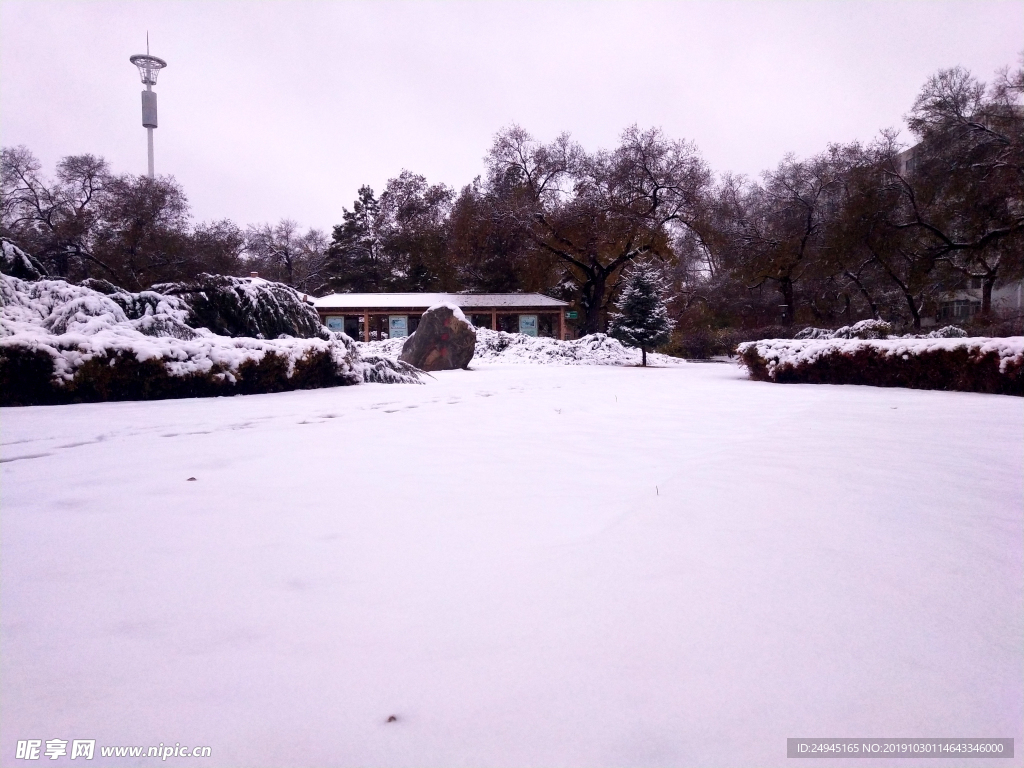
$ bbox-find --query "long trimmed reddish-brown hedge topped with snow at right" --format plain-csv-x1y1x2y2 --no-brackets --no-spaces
736,336,1024,395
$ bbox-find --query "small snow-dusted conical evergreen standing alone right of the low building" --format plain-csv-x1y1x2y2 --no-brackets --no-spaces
608,263,676,366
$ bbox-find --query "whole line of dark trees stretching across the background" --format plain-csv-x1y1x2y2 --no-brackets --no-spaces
0,60,1024,333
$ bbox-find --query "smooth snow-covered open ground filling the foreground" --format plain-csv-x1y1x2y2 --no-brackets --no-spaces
0,361,1024,768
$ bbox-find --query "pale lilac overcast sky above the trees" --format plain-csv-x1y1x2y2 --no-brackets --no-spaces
0,0,1024,230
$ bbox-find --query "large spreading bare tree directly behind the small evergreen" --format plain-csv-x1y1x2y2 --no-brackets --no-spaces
488,126,710,333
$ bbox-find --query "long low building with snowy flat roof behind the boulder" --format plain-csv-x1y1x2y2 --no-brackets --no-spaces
313,293,568,341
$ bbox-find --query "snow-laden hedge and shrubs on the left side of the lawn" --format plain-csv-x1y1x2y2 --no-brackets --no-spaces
0,253,418,406
